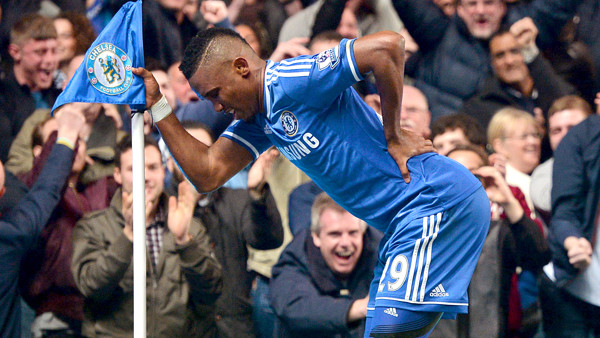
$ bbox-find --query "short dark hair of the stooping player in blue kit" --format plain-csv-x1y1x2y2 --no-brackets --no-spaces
179,27,249,80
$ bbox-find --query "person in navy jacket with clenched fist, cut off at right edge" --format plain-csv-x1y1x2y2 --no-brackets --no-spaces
540,115,600,337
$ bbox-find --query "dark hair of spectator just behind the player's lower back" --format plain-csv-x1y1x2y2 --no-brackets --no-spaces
431,114,486,147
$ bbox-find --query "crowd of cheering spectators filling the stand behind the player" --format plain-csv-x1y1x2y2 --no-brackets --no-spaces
0,0,600,337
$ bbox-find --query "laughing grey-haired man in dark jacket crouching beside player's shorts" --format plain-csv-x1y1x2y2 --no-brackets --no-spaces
269,193,382,337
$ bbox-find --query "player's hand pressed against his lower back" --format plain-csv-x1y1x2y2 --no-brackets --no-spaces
388,128,434,183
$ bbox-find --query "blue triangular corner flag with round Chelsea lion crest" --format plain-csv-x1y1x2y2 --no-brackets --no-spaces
52,0,146,113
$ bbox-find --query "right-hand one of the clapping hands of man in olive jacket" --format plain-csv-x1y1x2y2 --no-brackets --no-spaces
167,180,200,245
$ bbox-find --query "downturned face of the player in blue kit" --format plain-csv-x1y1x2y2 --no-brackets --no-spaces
190,62,259,120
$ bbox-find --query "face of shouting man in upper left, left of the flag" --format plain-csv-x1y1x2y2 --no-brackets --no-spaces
11,39,58,91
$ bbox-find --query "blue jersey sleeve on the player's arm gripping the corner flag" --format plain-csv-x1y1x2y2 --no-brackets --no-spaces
221,120,272,160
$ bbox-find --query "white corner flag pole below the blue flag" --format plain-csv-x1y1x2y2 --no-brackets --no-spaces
131,112,146,338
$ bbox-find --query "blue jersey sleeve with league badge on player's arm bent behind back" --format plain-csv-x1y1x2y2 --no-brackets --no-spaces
281,39,363,107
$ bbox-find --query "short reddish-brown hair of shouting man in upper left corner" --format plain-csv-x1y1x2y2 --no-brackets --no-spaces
10,14,56,46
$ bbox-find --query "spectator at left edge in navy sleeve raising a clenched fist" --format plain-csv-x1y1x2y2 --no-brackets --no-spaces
0,106,85,337
